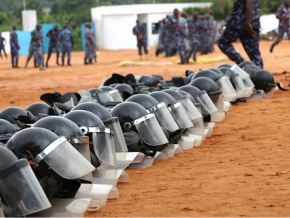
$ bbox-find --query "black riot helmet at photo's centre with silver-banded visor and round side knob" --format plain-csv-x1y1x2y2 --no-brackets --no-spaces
111,102,168,146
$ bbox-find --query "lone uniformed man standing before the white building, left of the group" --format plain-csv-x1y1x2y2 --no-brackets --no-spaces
133,20,148,60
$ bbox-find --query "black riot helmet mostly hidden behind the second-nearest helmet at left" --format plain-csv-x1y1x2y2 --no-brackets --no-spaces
33,116,93,182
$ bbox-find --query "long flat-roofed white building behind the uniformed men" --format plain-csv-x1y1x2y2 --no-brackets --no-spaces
91,2,211,50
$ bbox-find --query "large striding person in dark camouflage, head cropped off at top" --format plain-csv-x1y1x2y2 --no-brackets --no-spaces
218,0,263,68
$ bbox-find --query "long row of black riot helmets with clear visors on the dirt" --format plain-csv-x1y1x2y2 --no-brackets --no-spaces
0,62,276,216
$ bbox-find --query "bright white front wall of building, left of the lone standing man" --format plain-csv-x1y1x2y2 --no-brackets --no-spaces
99,15,137,50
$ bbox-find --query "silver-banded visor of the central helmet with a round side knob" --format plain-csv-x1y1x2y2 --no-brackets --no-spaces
134,114,168,146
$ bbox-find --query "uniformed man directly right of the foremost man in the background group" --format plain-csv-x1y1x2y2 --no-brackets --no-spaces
188,11,202,61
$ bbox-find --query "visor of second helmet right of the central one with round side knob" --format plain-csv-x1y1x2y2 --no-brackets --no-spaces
168,102,193,129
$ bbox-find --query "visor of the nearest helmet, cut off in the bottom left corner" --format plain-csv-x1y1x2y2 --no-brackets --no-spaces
0,159,51,216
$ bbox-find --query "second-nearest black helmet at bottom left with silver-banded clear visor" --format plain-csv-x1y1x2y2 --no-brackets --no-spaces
6,127,94,179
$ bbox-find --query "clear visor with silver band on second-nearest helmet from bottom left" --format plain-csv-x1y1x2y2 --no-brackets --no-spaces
34,137,95,179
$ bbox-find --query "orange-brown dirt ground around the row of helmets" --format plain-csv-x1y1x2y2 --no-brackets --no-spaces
0,41,290,217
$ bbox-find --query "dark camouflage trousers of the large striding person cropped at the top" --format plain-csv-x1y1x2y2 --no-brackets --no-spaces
218,28,263,69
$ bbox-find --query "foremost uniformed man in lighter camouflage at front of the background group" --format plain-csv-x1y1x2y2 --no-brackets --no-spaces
179,13,191,64
